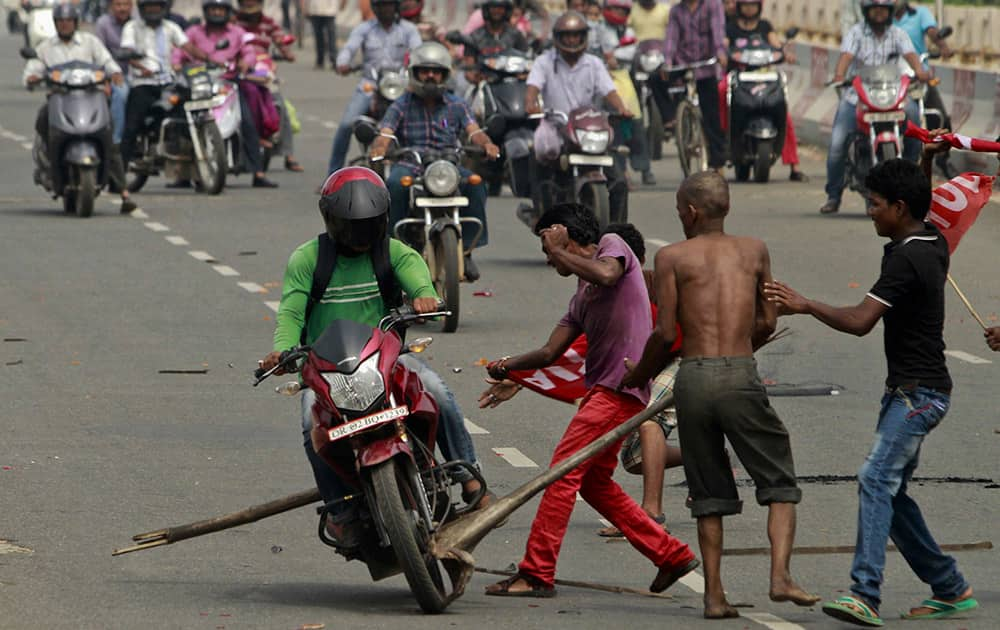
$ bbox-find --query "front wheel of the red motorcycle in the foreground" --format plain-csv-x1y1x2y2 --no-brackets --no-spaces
371,459,448,613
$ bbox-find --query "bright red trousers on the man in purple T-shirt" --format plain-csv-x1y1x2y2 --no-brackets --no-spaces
518,386,695,585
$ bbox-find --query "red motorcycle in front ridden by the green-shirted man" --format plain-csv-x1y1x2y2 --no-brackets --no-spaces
254,307,486,613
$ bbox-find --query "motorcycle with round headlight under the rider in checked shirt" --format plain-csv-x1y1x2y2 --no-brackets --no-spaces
375,146,483,332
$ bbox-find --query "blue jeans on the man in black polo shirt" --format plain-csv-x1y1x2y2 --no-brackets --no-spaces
851,387,969,609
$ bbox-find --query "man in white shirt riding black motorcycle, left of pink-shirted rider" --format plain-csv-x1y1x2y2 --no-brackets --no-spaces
121,0,208,168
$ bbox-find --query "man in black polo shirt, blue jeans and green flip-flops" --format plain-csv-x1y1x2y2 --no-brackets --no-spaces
764,158,978,626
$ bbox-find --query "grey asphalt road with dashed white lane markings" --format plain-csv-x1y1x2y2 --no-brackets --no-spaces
0,29,1000,630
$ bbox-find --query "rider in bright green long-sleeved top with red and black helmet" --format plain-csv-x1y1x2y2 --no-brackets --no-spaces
259,166,496,547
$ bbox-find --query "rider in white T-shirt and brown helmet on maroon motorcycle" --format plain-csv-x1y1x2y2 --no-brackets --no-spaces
521,11,633,223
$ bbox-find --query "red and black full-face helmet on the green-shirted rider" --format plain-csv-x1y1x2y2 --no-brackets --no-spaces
319,166,389,251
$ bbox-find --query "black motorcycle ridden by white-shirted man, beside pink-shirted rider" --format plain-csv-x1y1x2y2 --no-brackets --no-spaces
128,56,234,195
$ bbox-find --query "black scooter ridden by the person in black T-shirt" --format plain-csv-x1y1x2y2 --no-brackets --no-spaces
726,29,798,183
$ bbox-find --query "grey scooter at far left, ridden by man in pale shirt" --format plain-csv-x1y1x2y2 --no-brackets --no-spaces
31,51,114,217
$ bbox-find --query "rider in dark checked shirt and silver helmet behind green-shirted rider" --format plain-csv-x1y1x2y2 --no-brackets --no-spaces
370,42,500,282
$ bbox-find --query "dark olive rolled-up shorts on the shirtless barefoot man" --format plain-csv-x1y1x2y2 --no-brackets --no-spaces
674,357,802,517
